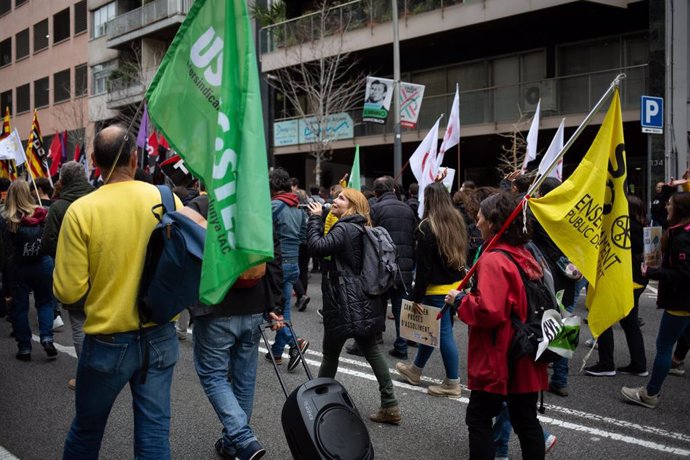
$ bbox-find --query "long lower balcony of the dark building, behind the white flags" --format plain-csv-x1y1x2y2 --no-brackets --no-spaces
271,65,648,154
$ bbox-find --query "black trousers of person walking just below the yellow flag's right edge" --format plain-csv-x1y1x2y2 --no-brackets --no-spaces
599,288,647,371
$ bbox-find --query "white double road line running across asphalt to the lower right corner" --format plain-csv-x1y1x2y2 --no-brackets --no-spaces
259,347,690,457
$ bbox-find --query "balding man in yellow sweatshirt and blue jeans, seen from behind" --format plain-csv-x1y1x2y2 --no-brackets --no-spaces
53,126,181,459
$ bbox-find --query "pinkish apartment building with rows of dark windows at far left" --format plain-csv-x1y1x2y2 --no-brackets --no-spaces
0,0,89,151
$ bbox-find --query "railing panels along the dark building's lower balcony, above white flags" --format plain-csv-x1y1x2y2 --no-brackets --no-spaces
274,65,648,145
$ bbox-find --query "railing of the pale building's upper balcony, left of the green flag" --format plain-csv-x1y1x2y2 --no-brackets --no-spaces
106,0,194,40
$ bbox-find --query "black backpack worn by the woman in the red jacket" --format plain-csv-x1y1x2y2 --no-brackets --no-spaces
496,249,561,369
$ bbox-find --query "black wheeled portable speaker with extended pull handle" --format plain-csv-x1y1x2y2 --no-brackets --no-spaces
259,321,374,460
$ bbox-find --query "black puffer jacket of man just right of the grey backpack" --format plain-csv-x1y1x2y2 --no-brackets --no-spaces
371,192,417,292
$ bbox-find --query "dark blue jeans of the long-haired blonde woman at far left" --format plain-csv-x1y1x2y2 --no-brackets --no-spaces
12,256,57,351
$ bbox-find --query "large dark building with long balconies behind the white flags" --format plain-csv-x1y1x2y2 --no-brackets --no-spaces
259,0,688,202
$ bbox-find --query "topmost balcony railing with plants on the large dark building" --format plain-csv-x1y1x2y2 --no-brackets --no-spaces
259,0,472,53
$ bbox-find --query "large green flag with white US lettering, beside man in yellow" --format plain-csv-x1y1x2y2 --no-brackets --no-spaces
146,0,273,304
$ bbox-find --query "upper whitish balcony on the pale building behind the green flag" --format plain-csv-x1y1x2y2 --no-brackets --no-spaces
106,0,194,48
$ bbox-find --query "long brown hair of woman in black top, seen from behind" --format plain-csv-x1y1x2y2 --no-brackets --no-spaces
420,182,467,270
